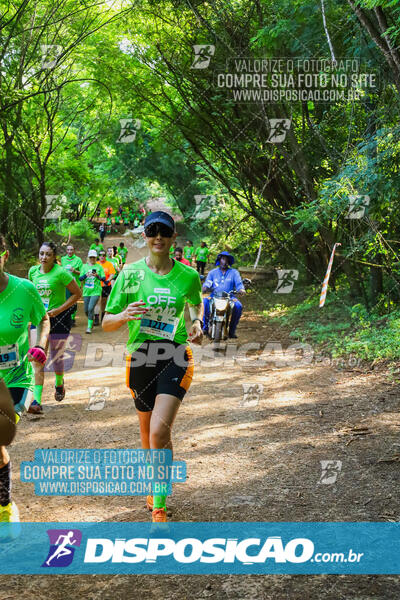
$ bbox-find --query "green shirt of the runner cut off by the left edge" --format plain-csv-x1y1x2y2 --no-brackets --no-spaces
0,275,46,391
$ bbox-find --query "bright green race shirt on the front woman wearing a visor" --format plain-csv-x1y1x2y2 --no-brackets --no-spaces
106,258,202,353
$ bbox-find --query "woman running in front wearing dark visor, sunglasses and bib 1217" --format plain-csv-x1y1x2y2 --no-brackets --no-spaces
103,211,203,522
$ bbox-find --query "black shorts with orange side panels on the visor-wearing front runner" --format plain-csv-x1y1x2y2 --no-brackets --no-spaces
126,340,194,412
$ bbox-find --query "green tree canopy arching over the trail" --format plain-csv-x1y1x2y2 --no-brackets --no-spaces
0,0,400,314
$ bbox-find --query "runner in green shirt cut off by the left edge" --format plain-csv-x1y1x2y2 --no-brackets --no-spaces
0,236,50,528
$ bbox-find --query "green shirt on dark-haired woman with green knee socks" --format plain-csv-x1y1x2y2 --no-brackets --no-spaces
28,263,74,310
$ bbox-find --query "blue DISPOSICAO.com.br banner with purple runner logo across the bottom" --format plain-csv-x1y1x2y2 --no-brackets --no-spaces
0,523,400,575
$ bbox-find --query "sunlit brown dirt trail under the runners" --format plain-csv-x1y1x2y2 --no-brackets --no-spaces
0,233,400,600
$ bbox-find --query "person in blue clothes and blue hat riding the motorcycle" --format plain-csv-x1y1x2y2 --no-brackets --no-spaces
203,252,246,338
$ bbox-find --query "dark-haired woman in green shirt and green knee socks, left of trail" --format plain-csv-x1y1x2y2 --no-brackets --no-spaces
28,242,82,413
